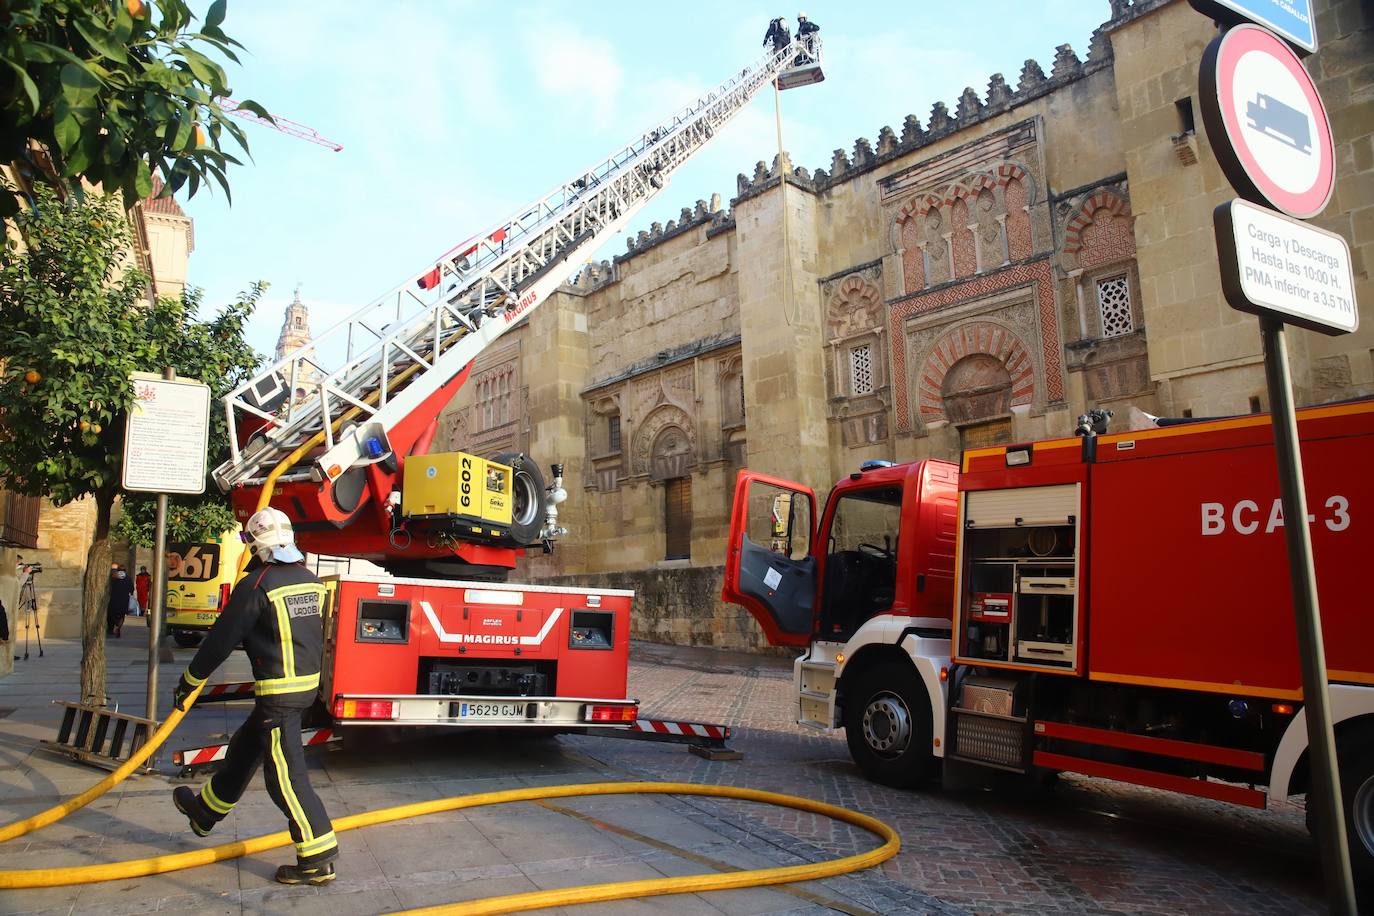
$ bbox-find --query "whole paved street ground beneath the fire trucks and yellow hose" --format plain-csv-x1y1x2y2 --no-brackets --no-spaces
0,631,1322,916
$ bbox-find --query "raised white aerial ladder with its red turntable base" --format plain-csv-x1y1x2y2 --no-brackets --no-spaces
214,37,824,574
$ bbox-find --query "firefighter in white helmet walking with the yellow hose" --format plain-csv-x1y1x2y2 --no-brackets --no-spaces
172,508,338,884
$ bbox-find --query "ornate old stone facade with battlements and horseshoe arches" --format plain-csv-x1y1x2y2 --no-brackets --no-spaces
444,0,1374,648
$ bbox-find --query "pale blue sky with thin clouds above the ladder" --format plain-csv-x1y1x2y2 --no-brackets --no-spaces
181,0,1109,353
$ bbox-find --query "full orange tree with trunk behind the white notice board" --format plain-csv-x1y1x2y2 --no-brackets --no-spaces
0,185,261,703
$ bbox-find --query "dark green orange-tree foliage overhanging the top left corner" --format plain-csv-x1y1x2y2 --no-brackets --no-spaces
0,0,271,217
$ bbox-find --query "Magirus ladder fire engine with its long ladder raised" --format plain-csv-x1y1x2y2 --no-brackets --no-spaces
206,40,824,729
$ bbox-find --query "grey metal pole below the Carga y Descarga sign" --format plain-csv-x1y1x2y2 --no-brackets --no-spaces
1260,317,1355,916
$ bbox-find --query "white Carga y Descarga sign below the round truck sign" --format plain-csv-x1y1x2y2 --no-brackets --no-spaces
1213,201,1360,335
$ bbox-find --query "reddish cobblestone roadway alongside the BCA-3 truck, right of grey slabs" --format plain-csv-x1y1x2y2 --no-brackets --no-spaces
563,644,1323,915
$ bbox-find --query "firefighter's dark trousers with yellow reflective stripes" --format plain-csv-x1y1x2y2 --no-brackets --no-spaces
201,703,338,865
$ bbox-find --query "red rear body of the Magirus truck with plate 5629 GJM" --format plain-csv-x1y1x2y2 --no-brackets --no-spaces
322,575,636,728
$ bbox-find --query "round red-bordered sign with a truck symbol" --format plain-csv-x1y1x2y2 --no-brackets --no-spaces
1198,25,1336,220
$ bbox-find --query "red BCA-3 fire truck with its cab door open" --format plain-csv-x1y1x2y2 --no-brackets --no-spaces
724,401,1374,880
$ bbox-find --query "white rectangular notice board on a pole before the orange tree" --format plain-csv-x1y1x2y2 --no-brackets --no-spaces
121,372,210,494
